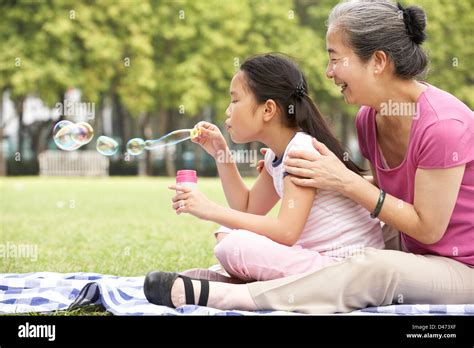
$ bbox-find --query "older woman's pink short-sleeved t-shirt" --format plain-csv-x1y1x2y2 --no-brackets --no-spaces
356,85,474,267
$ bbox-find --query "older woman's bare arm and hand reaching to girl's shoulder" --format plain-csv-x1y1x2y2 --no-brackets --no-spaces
284,139,465,244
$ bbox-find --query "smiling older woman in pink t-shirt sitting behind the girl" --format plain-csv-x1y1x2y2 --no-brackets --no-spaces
145,2,474,313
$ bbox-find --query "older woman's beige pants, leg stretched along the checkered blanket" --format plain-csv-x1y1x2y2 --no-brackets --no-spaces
247,225,474,313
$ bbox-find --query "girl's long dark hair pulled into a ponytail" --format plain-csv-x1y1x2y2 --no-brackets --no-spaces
240,54,365,175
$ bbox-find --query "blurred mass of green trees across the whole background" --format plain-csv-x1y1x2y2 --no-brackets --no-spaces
0,0,474,174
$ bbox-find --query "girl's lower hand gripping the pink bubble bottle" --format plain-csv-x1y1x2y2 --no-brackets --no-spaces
168,185,216,220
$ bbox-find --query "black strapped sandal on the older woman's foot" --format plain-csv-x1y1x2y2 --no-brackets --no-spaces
143,271,209,308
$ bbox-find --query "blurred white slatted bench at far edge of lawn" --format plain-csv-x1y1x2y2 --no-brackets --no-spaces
39,150,109,176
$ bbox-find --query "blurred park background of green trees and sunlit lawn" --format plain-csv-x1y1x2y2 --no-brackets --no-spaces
0,0,474,294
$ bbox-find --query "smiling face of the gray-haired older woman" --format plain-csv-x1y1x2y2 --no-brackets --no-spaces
326,26,375,105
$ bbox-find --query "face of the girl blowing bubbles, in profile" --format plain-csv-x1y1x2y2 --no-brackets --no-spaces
225,70,264,143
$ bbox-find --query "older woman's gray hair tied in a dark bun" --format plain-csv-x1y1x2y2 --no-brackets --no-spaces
328,0,428,79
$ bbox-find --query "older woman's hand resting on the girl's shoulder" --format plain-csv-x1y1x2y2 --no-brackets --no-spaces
283,138,357,192
